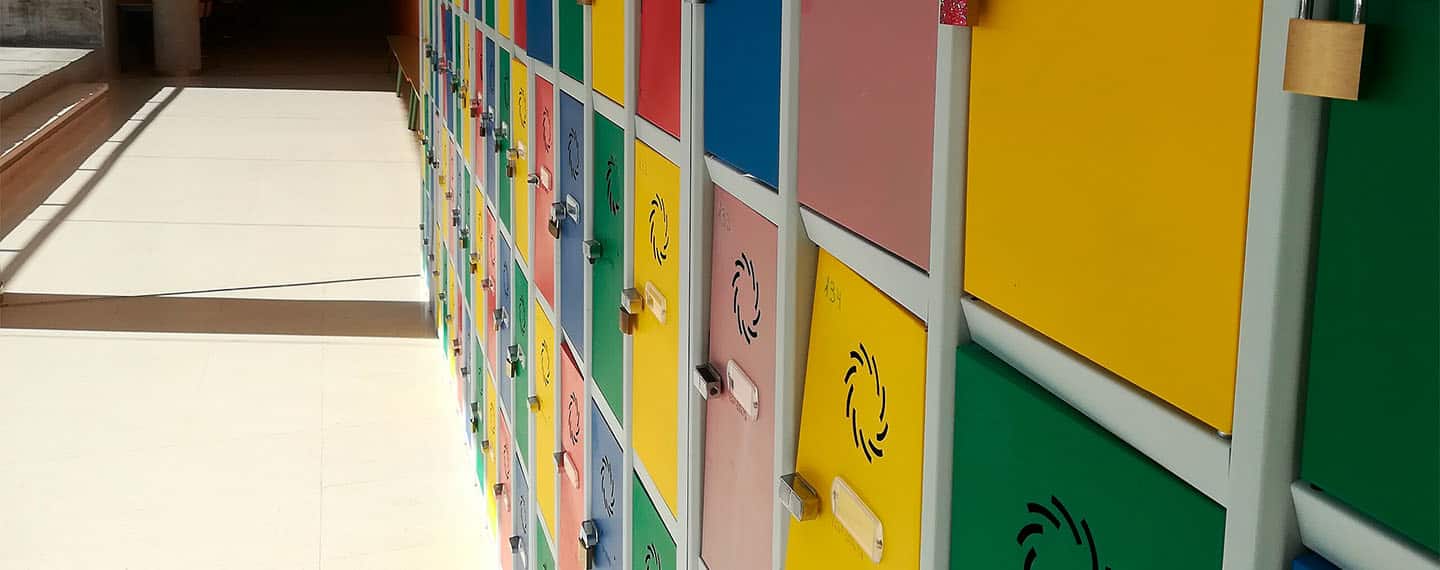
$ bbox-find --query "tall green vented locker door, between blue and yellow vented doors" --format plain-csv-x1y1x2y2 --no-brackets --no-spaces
590,112,625,422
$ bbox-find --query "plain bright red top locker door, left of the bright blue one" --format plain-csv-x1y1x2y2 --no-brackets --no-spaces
636,0,680,138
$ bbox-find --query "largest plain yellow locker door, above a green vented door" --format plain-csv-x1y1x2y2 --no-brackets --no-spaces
965,0,1260,432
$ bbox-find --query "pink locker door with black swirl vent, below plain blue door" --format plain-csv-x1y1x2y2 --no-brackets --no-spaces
700,186,776,570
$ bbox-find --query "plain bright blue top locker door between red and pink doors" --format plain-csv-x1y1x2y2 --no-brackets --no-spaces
704,0,780,189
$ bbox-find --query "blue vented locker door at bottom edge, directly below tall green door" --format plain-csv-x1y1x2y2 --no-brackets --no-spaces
588,402,628,570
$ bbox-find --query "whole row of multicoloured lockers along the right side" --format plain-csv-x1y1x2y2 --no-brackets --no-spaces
411,0,1440,570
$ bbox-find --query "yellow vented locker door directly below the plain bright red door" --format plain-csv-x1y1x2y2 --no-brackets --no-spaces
632,141,681,514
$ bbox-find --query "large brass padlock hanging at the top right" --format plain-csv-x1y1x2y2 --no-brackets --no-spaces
1283,0,1365,101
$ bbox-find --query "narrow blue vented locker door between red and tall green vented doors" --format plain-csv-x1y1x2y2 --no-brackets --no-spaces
559,91,589,351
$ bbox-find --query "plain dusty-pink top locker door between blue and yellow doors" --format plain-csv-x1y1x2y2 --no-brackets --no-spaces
794,0,939,269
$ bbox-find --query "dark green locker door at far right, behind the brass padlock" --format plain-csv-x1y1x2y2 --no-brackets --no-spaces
1300,0,1440,551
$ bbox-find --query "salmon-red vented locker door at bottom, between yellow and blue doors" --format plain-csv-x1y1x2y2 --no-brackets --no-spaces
554,345,586,570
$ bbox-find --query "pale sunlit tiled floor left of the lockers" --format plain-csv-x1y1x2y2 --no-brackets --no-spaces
0,70,498,570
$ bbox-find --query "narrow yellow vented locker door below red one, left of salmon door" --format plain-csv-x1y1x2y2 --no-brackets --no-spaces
531,295,559,533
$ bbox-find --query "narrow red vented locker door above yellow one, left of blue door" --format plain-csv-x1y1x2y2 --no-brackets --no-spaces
531,75,550,307
